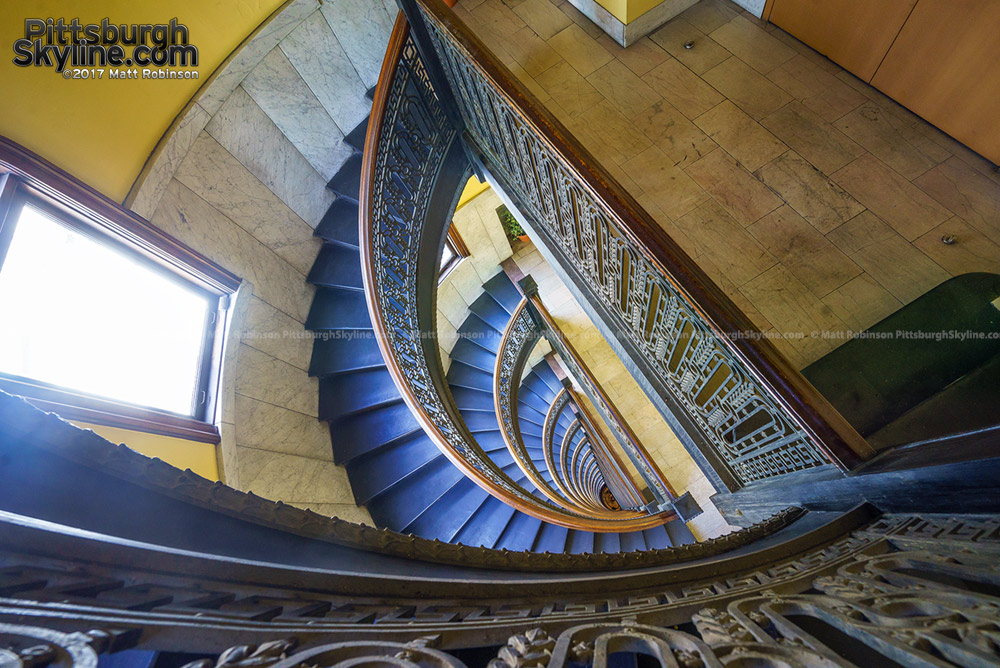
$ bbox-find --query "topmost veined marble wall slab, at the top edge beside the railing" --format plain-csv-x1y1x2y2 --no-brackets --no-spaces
320,0,396,89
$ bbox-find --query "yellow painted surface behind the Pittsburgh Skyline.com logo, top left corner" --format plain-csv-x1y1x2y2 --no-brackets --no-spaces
0,0,283,201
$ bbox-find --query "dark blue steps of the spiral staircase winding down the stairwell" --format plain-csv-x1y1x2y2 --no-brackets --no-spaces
306,121,694,553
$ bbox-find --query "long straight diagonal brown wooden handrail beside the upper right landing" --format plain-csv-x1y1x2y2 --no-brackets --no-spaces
406,0,875,482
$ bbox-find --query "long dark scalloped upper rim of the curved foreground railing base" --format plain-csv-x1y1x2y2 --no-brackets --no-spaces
0,391,804,576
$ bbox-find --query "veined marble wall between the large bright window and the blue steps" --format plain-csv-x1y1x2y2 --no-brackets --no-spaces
126,0,400,524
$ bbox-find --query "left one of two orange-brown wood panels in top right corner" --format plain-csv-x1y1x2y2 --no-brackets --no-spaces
769,0,916,81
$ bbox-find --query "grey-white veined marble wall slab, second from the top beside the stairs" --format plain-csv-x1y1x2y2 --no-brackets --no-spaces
281,12,371,134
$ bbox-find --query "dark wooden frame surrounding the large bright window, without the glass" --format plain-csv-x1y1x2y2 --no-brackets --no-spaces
0,137,241,443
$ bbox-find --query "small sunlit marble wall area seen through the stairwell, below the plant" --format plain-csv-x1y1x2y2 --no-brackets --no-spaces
437,189,512,372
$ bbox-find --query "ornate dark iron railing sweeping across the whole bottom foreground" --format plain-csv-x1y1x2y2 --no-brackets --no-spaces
0,376,1000,668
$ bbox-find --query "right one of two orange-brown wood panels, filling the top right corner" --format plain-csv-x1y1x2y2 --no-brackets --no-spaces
871,0,1000,163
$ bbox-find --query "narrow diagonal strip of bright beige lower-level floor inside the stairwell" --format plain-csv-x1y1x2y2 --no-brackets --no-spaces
514,244,731,540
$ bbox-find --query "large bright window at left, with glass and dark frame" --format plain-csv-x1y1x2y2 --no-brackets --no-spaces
0,142,240,443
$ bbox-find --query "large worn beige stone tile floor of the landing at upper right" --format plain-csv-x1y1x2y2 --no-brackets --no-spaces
455,0,1000,368
